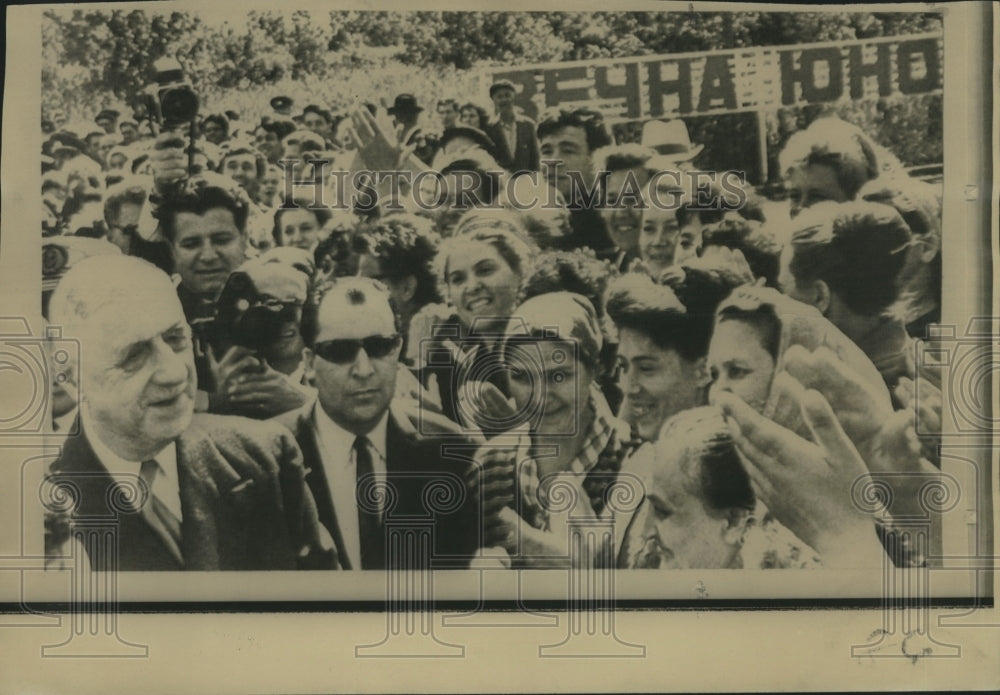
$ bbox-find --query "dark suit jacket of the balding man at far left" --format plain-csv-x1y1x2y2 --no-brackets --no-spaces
46,414,336,571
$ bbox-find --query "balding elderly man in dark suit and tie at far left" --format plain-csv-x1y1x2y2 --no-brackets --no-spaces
46,255,336,571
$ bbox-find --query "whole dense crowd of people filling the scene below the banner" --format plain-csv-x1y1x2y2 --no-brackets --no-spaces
42,80,941,570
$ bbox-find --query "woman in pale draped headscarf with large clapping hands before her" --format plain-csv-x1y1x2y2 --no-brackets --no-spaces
708,287,938,564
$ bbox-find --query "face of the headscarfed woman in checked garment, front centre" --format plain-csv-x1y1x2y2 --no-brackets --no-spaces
505,340,594,435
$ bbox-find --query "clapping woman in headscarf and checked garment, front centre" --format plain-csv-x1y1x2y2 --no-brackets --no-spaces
477,292,633,567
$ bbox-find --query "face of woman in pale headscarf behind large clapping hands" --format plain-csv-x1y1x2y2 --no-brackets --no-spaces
708,319,775,412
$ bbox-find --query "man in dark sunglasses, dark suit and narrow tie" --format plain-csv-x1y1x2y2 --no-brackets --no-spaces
279,277,481,569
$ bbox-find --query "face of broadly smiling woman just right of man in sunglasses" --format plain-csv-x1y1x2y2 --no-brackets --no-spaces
445,240,521,328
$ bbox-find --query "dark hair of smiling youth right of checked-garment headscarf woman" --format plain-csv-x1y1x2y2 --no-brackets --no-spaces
604,273,712,362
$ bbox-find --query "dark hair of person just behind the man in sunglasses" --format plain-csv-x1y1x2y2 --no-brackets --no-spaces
354,213,441,307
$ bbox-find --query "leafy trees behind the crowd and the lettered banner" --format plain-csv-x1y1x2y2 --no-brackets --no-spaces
42,8,942,188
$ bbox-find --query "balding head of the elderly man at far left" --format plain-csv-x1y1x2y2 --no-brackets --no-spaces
50,256,197,461
